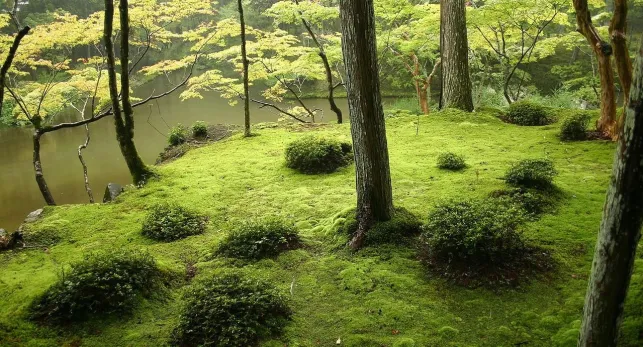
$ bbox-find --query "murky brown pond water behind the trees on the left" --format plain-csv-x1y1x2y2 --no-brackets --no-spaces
0,81,368,231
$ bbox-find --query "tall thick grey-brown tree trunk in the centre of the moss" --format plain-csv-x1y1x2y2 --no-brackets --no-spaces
340,0,393,249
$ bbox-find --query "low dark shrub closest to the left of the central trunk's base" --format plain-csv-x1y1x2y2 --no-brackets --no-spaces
216,219,300,260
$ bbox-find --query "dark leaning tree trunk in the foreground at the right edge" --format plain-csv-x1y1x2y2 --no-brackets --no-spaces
578,36,643,347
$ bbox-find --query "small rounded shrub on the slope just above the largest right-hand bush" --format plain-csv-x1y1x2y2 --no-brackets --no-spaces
505,159,558,188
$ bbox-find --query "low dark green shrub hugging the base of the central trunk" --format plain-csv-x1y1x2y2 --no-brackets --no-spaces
340,207,422,246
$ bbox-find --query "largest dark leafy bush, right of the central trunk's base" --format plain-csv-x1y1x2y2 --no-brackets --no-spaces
420,199,551,286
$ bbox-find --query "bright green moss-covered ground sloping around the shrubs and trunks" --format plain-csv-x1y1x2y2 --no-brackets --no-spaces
0,111,643,346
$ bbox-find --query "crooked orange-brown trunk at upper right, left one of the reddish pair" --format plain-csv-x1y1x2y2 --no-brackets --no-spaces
573,0,617,138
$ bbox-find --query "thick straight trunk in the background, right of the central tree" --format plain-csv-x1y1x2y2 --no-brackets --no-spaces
440,0,473,112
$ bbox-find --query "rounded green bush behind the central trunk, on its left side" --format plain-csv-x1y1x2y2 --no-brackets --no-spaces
286,135,353,174
